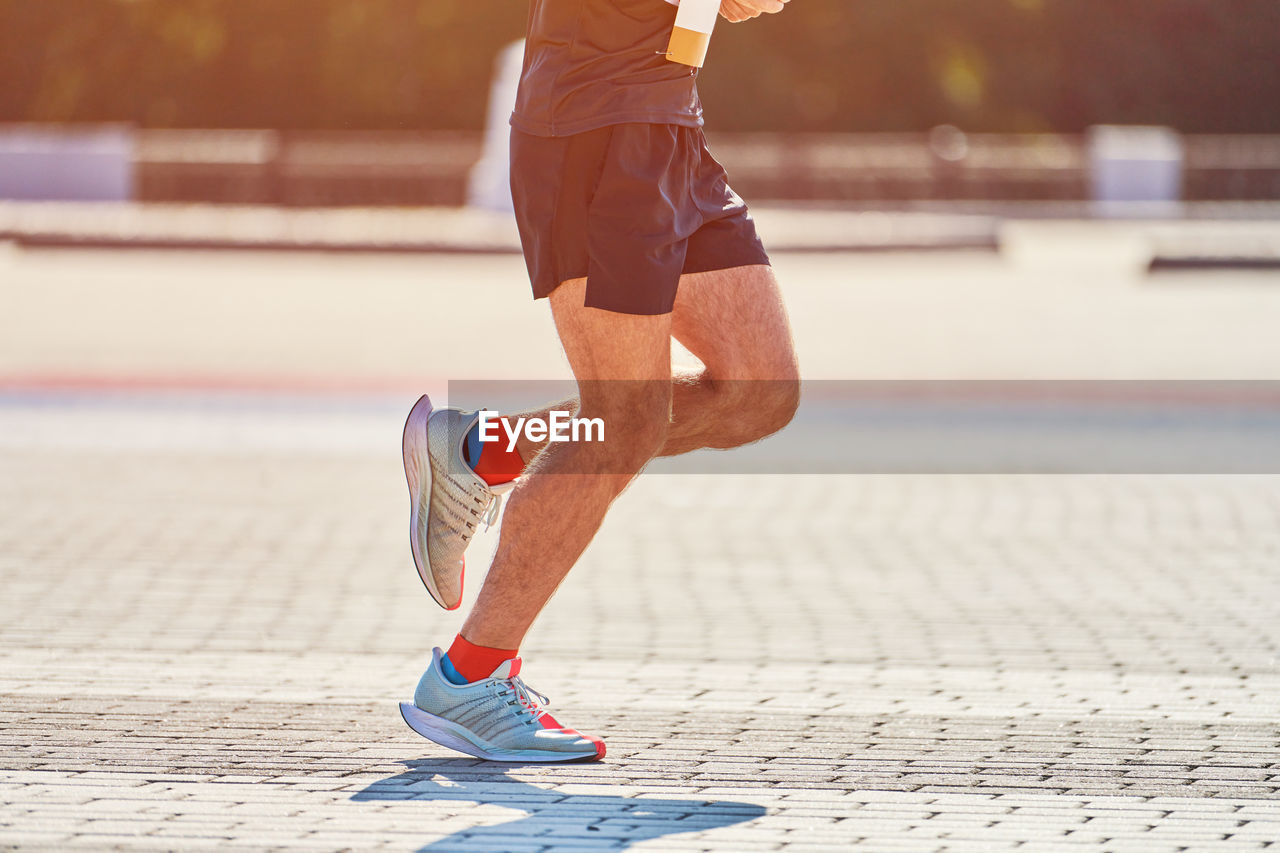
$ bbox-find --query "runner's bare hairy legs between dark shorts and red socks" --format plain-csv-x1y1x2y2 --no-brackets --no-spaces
462,266,799,648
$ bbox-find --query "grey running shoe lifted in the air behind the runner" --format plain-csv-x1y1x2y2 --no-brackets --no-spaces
401,394,515,610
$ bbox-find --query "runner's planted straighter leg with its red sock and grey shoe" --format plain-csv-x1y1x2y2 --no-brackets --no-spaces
401,279,672,761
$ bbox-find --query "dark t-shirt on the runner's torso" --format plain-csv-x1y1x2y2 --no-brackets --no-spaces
511,0,703,136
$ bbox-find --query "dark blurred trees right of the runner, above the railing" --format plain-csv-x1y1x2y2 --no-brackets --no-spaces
701,0,1280,132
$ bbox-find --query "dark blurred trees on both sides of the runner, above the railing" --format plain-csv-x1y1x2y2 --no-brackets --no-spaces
0,0,1280,132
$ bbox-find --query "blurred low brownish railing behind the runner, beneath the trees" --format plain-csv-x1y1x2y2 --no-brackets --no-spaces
20,128,1280,206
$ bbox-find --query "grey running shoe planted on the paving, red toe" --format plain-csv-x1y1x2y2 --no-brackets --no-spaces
401,648,604,762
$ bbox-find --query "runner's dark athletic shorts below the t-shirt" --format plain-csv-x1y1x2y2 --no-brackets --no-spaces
511,124,769,314
